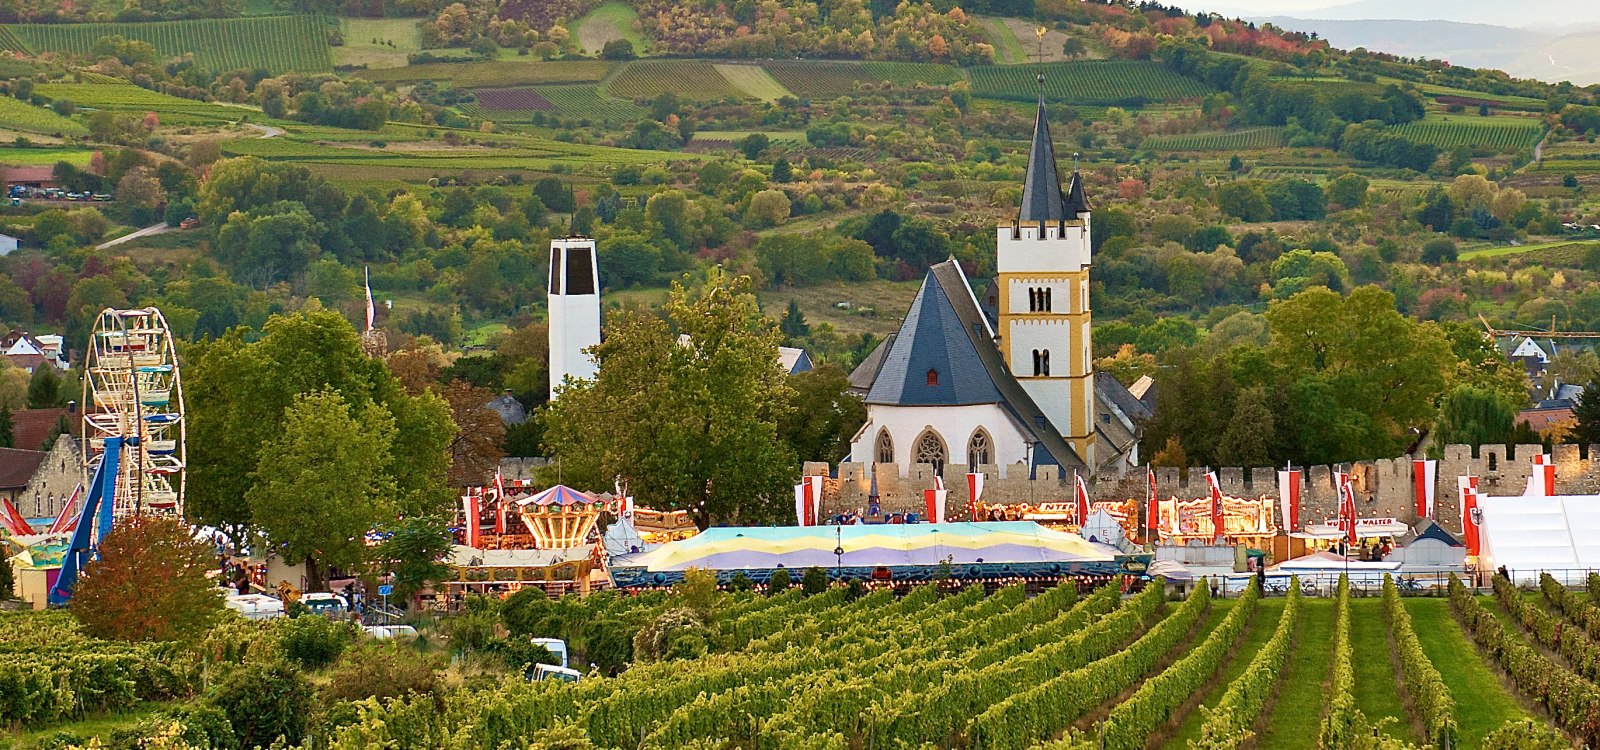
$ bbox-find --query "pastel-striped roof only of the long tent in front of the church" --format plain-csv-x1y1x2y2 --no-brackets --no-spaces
624,521,1114,571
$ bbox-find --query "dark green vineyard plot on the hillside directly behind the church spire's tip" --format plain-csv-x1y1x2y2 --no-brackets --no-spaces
971,61,1206,106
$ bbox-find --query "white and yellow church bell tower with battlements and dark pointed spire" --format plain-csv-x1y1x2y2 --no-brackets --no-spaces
995,75,1096,470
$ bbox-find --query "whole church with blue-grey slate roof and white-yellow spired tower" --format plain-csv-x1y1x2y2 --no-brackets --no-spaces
850,98,1150,477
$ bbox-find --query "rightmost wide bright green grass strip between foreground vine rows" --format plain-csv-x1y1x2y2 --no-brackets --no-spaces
1405,598,1530,747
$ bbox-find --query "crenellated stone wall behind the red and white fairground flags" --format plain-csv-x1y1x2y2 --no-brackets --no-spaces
805,445,1600,533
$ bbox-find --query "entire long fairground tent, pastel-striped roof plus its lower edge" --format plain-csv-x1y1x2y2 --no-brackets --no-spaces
611,521,1120,587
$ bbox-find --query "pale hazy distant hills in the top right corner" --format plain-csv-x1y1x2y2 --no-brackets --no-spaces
1253,15,1600,86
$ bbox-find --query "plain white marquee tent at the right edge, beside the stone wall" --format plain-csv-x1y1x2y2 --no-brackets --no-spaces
1478,494,1600,584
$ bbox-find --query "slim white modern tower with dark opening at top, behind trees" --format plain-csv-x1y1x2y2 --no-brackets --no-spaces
549,237,600,398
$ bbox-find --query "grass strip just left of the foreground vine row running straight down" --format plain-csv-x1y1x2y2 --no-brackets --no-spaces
1256,598,1333,750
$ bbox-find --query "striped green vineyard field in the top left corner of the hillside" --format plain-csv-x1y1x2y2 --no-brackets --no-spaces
8,16,333,74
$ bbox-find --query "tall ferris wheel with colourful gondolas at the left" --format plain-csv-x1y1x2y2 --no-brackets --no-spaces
83,307,187,518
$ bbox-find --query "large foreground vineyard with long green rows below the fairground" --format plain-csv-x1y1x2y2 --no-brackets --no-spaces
281,582,1580,750
